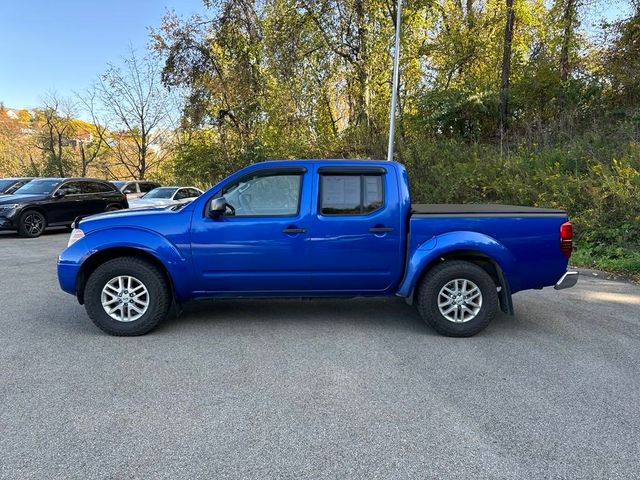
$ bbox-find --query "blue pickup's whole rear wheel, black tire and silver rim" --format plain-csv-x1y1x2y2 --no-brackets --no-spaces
417,260,498,337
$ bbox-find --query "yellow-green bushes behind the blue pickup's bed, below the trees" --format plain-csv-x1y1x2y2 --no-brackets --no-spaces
403,137,640,272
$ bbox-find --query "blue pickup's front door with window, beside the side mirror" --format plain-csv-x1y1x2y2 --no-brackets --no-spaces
191,167,311,296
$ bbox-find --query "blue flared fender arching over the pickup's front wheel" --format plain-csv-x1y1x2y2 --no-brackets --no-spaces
58,227,192,300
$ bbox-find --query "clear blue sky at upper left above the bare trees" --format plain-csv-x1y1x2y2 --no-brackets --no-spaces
0,0,204,108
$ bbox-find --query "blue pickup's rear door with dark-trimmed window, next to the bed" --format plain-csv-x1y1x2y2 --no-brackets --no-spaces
311,166,404,294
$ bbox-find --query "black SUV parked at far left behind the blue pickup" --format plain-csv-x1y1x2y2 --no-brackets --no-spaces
0,178,129,237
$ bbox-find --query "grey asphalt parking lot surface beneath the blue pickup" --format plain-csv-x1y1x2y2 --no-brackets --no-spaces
0,232,640,479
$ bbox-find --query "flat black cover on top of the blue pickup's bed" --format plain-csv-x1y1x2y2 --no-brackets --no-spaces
411,203,567,217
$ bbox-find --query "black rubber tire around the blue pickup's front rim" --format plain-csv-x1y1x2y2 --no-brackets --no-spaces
84,257,171,337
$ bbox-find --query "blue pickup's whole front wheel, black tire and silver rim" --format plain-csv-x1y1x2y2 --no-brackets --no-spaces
84,257,171,336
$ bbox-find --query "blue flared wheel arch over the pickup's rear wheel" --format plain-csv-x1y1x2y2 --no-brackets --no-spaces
398,231,514,297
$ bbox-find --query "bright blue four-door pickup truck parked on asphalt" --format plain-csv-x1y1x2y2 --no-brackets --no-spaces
58,160,577,337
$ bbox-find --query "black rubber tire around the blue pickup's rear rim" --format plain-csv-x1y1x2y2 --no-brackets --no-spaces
416,260,498,337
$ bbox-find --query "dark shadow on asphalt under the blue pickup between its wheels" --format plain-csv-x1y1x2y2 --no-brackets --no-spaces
158,298,437,335
